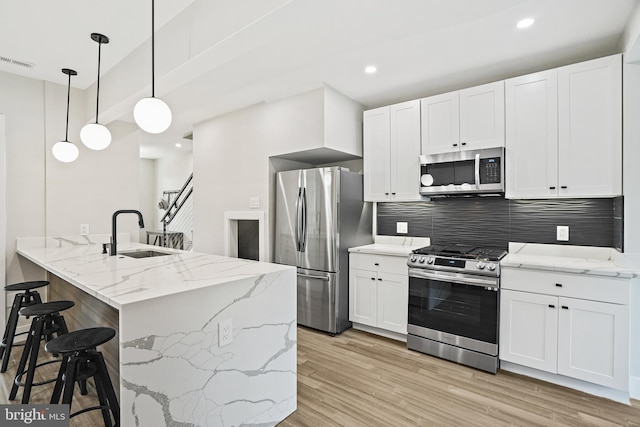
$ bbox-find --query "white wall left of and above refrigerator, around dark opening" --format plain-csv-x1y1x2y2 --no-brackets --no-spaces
193,88,362,260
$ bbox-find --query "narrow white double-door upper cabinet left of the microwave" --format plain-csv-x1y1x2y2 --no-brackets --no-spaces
363,100,420,202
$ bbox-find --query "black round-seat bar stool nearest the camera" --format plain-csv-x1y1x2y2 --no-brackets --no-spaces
44,328,120,427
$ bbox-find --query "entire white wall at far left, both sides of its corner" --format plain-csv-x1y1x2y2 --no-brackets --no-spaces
0,72,140,283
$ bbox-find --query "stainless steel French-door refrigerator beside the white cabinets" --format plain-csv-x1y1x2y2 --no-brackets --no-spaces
275,167,373,334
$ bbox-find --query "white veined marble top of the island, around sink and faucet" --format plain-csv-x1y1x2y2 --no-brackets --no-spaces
18,235,295,309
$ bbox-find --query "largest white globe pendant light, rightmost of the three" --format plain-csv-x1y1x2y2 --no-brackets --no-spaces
133,0,171,133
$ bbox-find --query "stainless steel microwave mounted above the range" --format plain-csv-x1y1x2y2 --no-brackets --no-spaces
420,147,504,196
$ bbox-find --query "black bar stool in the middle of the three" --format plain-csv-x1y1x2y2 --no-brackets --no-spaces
9,301,75,403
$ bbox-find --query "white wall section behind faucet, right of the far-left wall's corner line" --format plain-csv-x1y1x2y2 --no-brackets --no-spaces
45,83,140,240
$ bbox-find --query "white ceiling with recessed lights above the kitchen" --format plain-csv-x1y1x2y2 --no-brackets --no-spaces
0,0,638,157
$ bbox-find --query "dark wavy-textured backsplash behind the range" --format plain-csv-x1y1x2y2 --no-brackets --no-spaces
377,197,623,251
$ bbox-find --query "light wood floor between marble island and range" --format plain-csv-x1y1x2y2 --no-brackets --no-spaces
280,327,640,427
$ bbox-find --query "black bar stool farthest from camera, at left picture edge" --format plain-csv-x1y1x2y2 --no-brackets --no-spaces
0,280,49,372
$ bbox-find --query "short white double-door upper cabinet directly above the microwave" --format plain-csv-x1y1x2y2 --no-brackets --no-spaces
421,81,505,154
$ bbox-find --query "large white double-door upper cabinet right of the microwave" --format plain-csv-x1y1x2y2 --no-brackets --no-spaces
505,55,622,198
